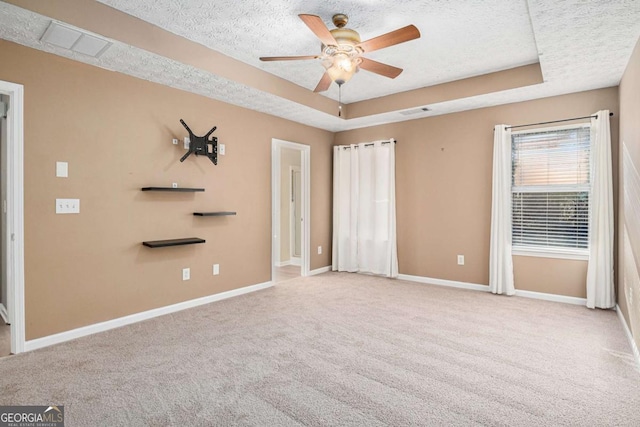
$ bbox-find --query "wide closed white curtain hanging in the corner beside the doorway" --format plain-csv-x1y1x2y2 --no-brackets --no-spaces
333,139,398,277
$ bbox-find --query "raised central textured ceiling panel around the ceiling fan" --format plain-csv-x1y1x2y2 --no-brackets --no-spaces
99,0,538,103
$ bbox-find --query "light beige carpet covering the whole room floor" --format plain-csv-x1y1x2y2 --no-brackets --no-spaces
0,273,640,426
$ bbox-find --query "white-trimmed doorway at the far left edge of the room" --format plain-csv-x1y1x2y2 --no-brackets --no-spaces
0,80,25,354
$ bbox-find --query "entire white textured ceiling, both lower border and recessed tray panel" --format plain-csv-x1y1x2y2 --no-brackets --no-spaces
0,0,640,131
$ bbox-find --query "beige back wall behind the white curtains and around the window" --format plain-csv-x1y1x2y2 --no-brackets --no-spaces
335,88,618,297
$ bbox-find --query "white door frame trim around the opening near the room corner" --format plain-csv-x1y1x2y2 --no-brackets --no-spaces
271,138,311,281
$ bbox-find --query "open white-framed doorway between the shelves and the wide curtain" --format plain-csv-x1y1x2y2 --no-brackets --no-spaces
271,139,310,282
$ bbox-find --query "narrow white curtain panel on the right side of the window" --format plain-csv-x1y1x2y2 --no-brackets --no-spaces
587,110,616,308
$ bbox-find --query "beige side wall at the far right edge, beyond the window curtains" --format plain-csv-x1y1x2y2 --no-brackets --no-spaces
617,36,640,347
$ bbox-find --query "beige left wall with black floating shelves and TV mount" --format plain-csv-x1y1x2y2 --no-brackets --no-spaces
0,41,333,339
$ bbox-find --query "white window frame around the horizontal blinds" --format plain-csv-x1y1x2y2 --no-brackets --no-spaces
509,122,593,261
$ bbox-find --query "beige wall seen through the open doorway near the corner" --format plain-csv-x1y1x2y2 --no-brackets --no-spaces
280,148,301,262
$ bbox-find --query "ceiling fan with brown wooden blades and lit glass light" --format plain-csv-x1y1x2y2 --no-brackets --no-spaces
260,13,420,92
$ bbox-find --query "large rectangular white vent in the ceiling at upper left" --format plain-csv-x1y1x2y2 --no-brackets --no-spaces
40,21,112,58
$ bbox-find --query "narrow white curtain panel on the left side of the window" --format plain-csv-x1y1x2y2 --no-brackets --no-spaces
489,125,515,295
